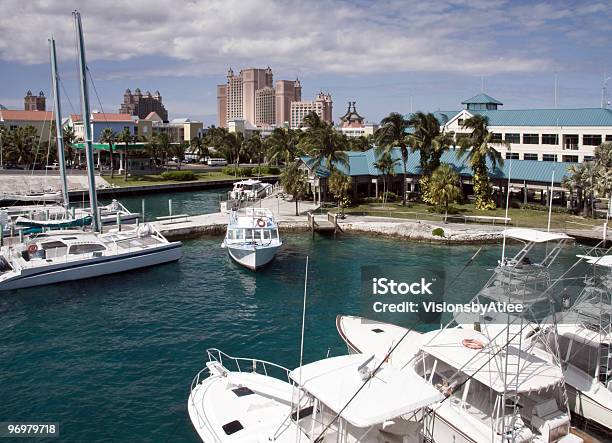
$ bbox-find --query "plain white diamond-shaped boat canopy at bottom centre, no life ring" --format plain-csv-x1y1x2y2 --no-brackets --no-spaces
289,354,443,428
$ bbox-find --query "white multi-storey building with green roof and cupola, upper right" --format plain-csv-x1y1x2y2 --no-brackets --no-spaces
434,94,612,162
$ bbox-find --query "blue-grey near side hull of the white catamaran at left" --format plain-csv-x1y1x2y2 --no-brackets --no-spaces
0,242,181,291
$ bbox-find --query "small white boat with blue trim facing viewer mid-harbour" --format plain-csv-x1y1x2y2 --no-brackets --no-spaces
221,208,283,271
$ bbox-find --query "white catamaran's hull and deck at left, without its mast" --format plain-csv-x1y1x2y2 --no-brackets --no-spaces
0,224,181,291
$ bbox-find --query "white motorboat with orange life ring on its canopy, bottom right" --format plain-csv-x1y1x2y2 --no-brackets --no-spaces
336,316,582,443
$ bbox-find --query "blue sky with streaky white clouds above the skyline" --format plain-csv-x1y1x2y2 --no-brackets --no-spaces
0,0,612,125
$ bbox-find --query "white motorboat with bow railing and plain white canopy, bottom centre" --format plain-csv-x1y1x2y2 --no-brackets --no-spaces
187,349,442,443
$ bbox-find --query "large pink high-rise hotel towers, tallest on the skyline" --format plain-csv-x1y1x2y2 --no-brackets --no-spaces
217,66,302,127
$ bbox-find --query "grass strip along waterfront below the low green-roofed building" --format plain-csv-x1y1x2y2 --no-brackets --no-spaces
346,203,604,229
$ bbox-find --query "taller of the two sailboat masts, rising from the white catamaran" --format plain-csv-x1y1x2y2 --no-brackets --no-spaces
72,11,100,232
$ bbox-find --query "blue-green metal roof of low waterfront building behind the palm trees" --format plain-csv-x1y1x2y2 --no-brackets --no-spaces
301,148,575,184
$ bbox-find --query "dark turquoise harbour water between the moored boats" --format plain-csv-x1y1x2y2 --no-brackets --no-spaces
0,192,604,442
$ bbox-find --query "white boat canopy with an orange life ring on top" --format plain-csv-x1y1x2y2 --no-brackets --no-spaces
422,328,563,393
